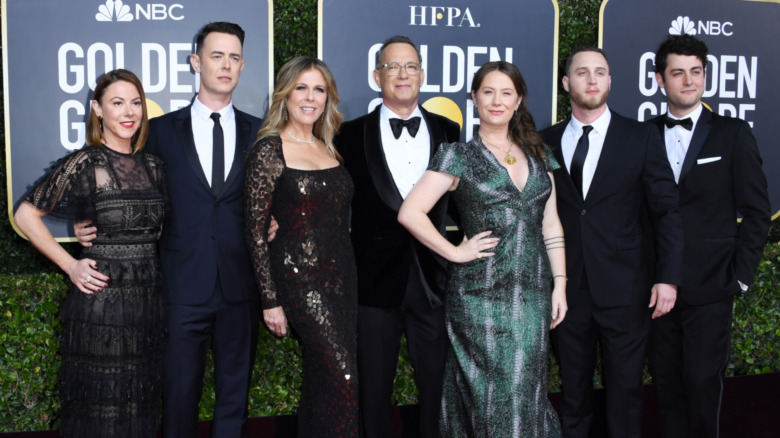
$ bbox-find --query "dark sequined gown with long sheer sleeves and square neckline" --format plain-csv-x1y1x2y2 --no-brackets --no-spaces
245,137,358,438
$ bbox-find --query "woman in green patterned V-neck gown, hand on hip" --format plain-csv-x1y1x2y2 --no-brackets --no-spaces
398,61,567,438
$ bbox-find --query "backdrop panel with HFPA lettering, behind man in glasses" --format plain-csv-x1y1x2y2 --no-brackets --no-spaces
319,0,559,140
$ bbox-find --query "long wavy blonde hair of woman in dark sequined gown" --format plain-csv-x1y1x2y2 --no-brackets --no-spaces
257,56,344,161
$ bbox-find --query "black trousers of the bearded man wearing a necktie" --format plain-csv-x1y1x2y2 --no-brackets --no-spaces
552,281,650,438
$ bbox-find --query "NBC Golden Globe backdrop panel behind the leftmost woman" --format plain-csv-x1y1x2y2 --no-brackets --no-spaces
2,0,273,238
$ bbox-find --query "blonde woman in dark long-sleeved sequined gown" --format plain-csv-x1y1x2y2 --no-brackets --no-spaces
245,57,358,437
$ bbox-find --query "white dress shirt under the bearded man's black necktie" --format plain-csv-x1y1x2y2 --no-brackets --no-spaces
561,108,612,199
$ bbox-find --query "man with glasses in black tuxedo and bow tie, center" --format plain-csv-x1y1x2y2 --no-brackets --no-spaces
336,36,460,438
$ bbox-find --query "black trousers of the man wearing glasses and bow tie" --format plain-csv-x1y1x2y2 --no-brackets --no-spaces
358,267,447,438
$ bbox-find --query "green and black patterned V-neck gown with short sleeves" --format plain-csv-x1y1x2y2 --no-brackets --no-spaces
429,137,561,438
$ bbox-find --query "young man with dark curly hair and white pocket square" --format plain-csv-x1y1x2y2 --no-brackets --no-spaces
649,35,771,438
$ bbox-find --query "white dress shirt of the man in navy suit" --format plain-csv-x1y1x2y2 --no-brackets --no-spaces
190,98,236,185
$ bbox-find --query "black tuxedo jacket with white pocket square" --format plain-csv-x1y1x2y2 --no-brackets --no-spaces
650,108,772,305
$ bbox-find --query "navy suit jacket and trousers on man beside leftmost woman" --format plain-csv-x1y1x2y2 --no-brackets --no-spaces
146,106,261,437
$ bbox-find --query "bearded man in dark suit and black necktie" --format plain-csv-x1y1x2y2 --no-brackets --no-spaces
541,48,682,438
